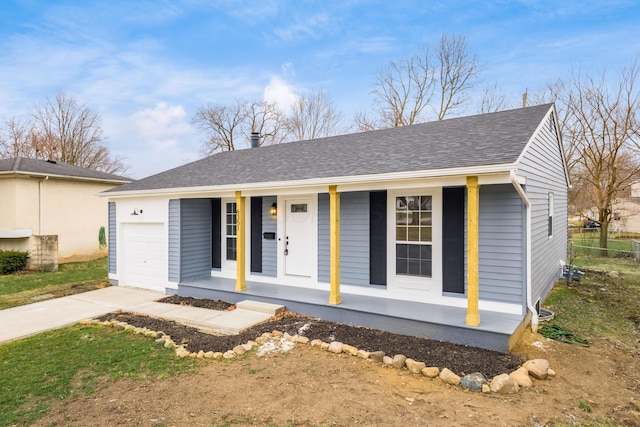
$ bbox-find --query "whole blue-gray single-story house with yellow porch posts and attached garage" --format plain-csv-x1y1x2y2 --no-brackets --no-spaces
101,104,569,351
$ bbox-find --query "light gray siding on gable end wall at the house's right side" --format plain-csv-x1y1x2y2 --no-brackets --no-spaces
518,115,568,304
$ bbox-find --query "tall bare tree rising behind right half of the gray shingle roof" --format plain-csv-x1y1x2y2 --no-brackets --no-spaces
362,34,482,128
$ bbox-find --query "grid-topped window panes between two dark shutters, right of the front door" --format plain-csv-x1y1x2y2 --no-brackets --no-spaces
395,195,433,277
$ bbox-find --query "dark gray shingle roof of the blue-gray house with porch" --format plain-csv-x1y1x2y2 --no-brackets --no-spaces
106,104,553,194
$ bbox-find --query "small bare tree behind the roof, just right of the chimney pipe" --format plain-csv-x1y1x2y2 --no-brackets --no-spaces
287,90,340,140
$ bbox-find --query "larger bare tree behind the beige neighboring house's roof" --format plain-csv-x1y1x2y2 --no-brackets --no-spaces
33,92,127,173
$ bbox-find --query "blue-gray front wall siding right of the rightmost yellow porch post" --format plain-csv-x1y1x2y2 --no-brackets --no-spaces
478,184,526,304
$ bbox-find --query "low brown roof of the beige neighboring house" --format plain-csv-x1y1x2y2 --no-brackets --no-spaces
0,157,131,183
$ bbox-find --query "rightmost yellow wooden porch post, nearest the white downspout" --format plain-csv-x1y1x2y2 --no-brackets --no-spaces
467,176,480,326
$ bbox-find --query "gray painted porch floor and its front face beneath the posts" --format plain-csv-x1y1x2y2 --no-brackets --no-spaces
178,277,527,352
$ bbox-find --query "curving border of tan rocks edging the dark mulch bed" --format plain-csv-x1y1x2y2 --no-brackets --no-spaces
80,319,556,394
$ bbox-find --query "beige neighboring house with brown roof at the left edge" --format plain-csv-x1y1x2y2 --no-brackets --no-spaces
0,157,131,270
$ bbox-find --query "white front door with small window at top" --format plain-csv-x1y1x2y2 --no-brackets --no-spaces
284,198,316,277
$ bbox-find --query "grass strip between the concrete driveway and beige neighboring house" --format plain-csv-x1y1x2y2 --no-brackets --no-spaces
0,257,108,309
